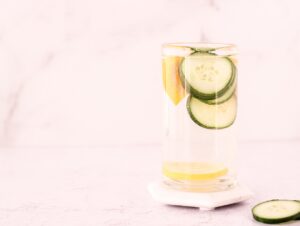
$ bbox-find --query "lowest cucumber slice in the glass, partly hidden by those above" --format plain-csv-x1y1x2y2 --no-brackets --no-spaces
187,95,237,129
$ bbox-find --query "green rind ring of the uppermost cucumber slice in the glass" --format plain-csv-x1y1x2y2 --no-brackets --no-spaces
180,51,236,100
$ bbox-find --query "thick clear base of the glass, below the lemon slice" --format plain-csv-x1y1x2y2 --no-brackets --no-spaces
163,177,237,192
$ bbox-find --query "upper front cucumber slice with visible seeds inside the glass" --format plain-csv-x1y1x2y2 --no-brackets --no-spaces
180,52,235,100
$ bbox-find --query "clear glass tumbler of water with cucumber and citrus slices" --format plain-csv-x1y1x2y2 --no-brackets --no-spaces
162,43,237,192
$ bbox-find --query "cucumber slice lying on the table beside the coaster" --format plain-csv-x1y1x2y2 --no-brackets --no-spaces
252,199,300,224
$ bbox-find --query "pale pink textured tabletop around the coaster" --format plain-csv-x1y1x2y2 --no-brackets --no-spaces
0,141,300,226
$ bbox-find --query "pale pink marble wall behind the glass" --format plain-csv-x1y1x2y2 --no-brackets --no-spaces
0,0,300,146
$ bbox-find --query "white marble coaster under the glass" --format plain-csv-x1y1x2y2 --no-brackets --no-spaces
148,182,253,210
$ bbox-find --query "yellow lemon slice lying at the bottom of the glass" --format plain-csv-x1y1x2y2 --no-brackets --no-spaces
163,162,228,181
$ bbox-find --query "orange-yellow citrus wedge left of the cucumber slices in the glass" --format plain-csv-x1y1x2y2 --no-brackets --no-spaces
162,56,185,105
